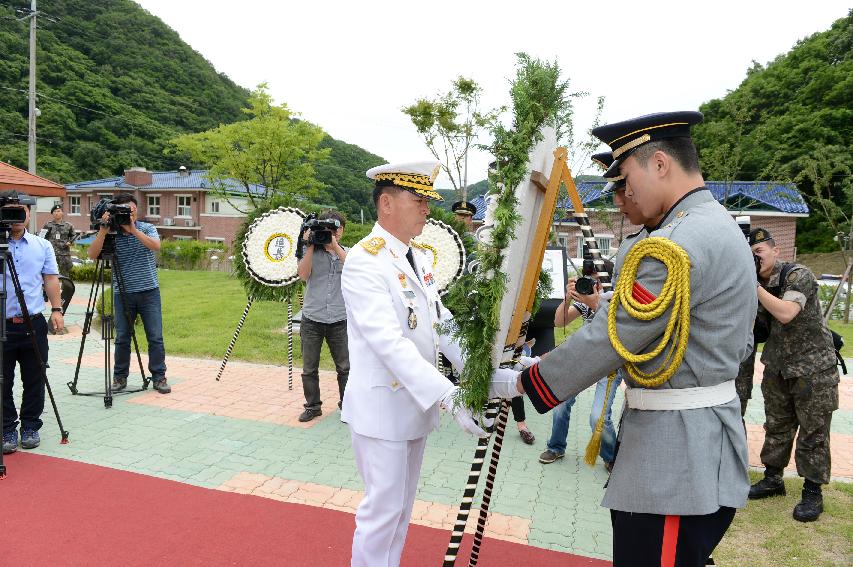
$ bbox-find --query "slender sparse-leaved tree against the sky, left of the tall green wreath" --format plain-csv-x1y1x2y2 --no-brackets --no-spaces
402,76,503,200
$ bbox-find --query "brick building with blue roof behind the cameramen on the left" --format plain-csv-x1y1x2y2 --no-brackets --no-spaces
63,167,263,247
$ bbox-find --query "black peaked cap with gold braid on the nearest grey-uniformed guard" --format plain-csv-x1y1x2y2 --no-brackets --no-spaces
592,110,703,163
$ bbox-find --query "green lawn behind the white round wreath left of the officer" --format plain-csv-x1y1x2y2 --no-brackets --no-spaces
130,270,334,370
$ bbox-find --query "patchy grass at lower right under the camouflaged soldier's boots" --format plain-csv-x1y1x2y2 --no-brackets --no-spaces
714,473,853,567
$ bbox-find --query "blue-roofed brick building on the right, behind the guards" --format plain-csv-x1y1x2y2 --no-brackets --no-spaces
472,181,809,261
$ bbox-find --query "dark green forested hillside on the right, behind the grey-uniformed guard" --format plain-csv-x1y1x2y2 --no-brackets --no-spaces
695,13,853,252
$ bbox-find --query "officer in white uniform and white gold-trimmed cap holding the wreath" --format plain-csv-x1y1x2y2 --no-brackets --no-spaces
341,161,486,567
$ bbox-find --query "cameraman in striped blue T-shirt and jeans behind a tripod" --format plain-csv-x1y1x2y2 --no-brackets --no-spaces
89,193,172,394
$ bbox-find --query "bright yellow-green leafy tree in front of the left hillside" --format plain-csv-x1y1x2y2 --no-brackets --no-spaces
169,84,330,213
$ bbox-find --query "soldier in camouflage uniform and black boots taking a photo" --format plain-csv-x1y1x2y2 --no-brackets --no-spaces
749,228,839,522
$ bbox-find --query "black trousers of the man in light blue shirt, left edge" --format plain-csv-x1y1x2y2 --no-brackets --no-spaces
3,313,48,433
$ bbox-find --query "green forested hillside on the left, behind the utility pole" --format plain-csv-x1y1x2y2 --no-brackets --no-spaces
0,0,383,221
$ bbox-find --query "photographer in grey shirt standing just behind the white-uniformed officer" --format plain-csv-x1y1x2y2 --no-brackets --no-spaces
297,211,349,422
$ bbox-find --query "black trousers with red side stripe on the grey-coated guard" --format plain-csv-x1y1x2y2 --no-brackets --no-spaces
610,507,735,567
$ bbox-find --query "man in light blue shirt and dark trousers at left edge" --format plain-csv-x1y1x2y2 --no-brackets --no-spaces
0,191,64,453
